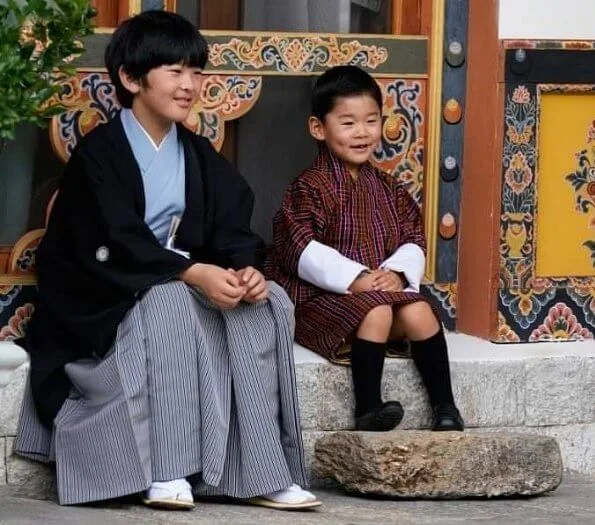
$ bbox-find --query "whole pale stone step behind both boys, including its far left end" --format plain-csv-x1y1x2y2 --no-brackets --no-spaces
0,334,595,492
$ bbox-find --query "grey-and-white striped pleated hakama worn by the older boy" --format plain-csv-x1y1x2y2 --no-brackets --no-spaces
15,281,307,504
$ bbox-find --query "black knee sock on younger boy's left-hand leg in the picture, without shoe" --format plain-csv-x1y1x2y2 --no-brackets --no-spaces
351,338,386,417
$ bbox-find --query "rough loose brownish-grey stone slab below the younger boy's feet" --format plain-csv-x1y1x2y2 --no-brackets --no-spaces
314,430,562,499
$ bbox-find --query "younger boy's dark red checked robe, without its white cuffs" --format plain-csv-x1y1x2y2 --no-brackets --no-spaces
266,147,436,364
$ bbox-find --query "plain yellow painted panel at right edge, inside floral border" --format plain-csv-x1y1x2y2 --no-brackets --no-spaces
535,92,595,277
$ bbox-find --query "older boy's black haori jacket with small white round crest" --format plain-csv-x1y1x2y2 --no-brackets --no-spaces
25,116,262,427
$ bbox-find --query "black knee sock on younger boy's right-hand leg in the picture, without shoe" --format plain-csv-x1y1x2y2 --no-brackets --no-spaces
411,328,454,406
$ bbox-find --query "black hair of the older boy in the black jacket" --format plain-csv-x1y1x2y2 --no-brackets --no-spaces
105,11,208,108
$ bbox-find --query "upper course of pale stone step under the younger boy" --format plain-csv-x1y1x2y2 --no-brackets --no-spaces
295,334,595,430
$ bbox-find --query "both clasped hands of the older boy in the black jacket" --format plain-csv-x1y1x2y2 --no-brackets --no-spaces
180,263,269,309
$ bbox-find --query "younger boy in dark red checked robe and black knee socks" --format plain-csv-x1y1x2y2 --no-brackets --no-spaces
267,66,463,431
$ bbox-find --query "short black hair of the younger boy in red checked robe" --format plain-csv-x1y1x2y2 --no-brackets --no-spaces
312,66,382,121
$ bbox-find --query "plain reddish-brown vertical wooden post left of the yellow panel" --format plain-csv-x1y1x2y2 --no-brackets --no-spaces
457,0,504,339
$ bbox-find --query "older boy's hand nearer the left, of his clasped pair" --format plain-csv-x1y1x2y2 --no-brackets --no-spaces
180,263,247,309
